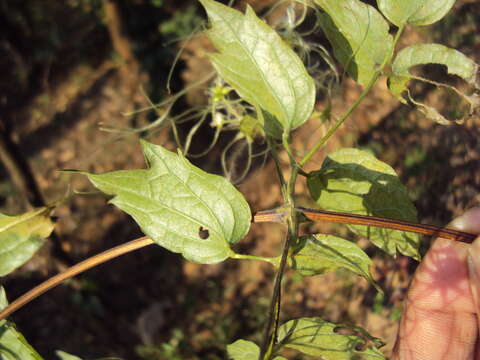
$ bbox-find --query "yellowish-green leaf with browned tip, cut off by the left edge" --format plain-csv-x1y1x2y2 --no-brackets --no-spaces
0,207,54,276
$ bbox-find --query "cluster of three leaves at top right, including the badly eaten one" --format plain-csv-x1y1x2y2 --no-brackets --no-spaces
315,0,480,125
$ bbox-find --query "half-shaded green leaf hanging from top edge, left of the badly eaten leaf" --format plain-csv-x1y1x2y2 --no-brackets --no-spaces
315,0,393,85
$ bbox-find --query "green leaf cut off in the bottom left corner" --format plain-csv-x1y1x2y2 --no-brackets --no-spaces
0,320,42,360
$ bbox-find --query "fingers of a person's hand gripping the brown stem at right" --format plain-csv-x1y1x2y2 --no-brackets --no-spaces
392,208,480,360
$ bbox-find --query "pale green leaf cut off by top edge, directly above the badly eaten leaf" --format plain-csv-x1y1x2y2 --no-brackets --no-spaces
377,0,455,27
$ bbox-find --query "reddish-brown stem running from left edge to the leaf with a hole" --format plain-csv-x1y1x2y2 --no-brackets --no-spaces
0,236,154,320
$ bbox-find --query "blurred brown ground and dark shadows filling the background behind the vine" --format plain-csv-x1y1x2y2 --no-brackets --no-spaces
0,0,480,359
